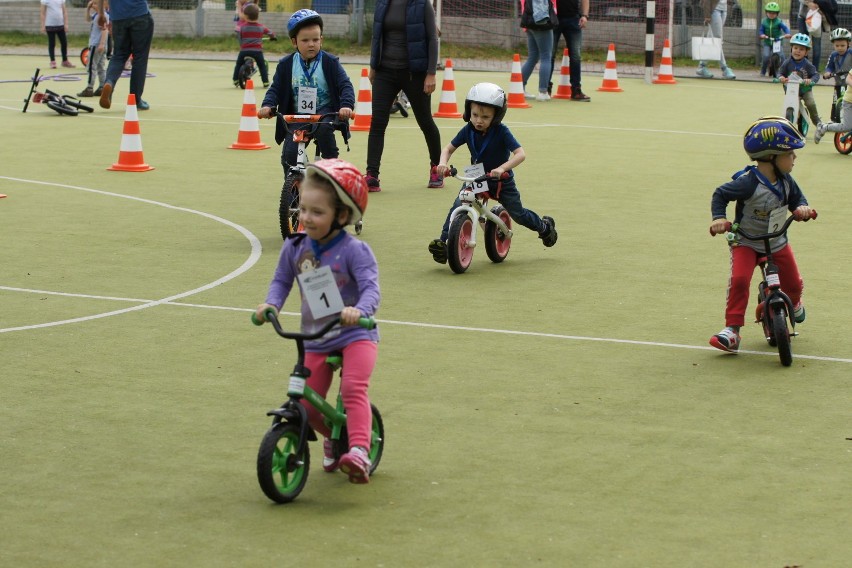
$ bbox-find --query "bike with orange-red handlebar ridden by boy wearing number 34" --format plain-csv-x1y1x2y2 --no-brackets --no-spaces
276,112,356,239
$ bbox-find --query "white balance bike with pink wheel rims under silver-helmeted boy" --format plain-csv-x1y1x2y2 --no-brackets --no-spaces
447,166,512,274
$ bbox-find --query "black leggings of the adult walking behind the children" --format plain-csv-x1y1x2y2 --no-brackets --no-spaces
367,69,441,177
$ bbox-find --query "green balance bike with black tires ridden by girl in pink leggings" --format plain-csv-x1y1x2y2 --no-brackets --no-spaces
251,309,385,503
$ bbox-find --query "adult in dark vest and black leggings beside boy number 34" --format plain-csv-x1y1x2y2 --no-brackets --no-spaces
366,0,444,191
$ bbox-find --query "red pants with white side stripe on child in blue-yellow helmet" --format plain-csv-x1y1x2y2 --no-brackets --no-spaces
725,244,804,326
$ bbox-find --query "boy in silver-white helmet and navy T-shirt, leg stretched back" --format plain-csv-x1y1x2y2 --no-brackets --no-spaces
429,83,557,264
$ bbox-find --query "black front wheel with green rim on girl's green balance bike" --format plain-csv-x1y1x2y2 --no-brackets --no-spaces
257,422,311,503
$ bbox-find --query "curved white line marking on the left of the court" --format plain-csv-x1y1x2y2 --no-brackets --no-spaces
0,176,263,333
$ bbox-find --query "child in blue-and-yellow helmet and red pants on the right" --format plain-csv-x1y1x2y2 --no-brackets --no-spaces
710,116,811,353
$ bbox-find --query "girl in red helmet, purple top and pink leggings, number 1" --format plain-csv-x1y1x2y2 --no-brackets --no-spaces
254,159,380,499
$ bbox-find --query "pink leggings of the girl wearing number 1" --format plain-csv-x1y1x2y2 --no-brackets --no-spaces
303,340,378,450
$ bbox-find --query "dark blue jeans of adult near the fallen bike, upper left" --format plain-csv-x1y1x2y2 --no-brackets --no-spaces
106,13,154,104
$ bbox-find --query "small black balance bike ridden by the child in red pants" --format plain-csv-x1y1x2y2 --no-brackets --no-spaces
726,211,817,367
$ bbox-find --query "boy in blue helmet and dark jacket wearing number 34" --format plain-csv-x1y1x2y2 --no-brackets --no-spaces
257,10,355,209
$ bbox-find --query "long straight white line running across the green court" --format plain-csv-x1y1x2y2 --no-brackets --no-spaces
0,286,852,363
